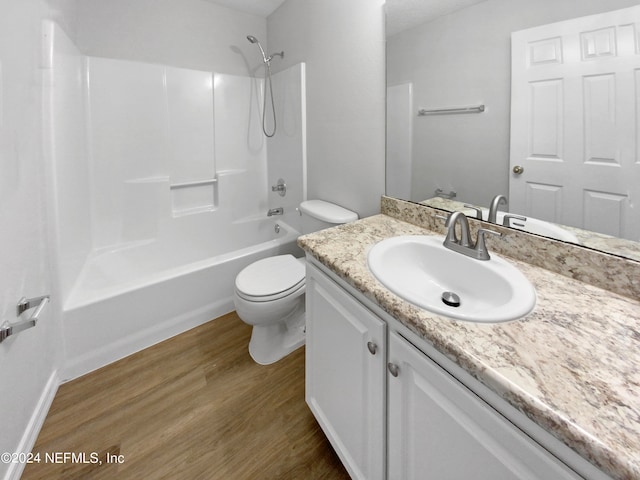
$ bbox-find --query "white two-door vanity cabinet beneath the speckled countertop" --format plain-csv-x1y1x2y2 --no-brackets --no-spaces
306,262,583,480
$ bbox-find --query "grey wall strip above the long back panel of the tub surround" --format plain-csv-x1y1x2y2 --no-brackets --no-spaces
77,0,267,75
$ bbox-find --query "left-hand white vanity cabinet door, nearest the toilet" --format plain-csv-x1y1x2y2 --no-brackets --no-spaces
305,265,386,480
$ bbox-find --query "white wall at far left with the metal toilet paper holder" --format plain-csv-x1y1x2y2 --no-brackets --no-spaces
0,0,73,478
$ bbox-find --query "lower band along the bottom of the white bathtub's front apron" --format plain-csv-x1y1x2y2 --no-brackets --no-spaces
61,298,234,383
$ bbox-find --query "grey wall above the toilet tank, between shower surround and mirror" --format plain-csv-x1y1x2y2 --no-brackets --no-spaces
267,0,385,216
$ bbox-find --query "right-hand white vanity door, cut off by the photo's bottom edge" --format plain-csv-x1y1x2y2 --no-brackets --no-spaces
388,332,581,480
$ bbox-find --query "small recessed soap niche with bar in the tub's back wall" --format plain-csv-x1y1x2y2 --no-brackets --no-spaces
169,178,218,218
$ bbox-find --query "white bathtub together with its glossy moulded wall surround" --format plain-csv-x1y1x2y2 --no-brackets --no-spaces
44,22,305,379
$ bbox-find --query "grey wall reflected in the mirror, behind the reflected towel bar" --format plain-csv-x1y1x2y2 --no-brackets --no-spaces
387,0,637,205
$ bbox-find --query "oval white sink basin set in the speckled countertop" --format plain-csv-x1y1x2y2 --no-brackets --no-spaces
367,235,536,322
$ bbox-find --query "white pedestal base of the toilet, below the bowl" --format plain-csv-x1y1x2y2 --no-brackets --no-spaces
249,308,305,365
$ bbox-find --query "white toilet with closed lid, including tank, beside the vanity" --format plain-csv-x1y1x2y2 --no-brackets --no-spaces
233,200,358,365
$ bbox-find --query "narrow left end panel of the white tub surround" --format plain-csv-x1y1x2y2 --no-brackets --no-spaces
42,21,92,301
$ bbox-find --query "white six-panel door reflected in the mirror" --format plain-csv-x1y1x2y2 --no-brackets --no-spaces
509,6,640,240
